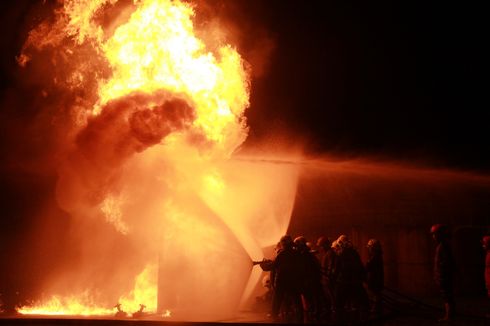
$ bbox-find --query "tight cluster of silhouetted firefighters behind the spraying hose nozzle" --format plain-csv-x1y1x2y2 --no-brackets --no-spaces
255,235,384,323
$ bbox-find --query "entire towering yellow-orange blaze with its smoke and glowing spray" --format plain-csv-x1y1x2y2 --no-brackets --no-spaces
18,0,297,319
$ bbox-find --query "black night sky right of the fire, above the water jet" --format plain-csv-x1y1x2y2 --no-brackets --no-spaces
238,1,490,170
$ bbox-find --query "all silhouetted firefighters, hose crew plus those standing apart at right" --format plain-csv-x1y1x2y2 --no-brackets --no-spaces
255,224,490,324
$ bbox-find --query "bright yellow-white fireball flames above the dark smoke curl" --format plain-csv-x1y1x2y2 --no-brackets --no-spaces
99,0,249,149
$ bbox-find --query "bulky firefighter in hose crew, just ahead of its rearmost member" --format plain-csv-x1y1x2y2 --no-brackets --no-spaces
332,235,369,324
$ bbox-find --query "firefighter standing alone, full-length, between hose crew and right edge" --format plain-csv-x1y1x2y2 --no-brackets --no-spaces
430,224,455,322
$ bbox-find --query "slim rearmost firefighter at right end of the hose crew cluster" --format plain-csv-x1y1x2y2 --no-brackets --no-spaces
366,239,384,316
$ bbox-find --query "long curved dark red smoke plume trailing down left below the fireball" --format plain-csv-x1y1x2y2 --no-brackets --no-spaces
58,93,195,211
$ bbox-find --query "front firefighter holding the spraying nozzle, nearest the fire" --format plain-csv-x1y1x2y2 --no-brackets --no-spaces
260,235,303,323
